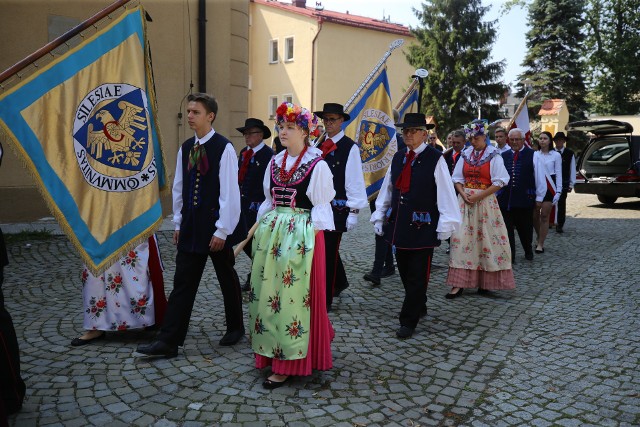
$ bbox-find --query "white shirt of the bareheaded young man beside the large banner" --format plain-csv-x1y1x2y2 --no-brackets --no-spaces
172,128,240,240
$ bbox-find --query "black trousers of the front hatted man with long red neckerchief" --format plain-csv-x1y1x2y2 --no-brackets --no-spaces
396,248,433,329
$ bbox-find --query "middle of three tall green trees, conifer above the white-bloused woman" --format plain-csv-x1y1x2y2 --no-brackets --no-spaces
518,0,588,120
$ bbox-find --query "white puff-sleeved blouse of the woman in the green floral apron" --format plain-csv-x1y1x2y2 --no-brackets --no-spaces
258,147,336,230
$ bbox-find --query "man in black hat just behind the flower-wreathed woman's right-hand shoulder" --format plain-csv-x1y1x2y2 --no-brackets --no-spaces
314,103,367,311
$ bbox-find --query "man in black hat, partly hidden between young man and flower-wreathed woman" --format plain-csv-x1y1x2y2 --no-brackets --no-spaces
236,117,273,291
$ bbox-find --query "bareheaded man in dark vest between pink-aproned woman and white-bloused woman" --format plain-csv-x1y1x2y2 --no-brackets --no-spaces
497,128,536,263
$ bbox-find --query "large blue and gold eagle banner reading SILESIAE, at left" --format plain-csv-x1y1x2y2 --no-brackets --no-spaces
0,6,167,273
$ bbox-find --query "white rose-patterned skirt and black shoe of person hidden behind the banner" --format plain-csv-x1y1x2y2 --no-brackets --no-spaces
71,235,167,347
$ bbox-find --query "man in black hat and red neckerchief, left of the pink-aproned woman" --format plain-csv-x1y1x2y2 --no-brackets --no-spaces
371,113,462,339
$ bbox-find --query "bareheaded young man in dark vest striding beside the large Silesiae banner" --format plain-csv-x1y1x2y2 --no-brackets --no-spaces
137,93,246,358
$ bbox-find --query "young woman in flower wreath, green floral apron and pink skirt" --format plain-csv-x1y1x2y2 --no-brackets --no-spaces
249,103,335,389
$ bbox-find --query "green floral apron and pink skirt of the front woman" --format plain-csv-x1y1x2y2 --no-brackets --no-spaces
249,208,334,375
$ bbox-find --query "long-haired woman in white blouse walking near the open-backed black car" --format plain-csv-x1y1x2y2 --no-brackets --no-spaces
533,131,562,254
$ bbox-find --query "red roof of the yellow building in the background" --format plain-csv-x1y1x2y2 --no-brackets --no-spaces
251,0,411,36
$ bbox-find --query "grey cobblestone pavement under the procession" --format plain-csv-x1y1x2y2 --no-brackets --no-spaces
3,194,640,427
